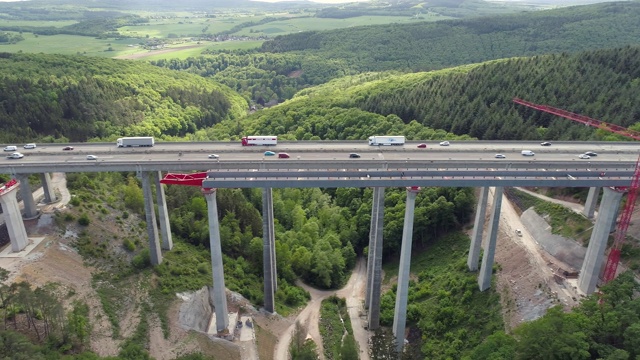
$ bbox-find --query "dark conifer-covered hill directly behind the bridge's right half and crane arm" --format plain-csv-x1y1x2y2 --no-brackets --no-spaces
208,47,640,140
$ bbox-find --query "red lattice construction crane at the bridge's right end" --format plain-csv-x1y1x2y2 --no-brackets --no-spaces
513,98,640,283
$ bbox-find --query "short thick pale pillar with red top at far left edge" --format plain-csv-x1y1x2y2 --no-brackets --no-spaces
0,180,29,252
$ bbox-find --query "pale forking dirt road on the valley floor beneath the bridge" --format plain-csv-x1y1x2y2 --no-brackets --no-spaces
273,259,369,360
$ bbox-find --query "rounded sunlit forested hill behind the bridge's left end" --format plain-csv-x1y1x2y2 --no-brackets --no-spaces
0,53,248,143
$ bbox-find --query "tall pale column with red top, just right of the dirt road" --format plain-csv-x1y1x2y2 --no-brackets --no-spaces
393,188,420,353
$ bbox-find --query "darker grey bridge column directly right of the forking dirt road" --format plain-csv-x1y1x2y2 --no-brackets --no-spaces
365,187,384,330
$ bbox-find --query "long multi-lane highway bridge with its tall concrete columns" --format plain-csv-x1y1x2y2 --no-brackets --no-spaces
0,141,640,342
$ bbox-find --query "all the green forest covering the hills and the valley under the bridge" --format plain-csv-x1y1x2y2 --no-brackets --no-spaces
0,1,640,360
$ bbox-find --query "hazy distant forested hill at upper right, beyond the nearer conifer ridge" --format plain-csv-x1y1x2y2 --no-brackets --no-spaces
262,1,640,72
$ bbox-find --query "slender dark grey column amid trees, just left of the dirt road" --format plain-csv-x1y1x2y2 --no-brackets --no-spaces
262,188,278,313
